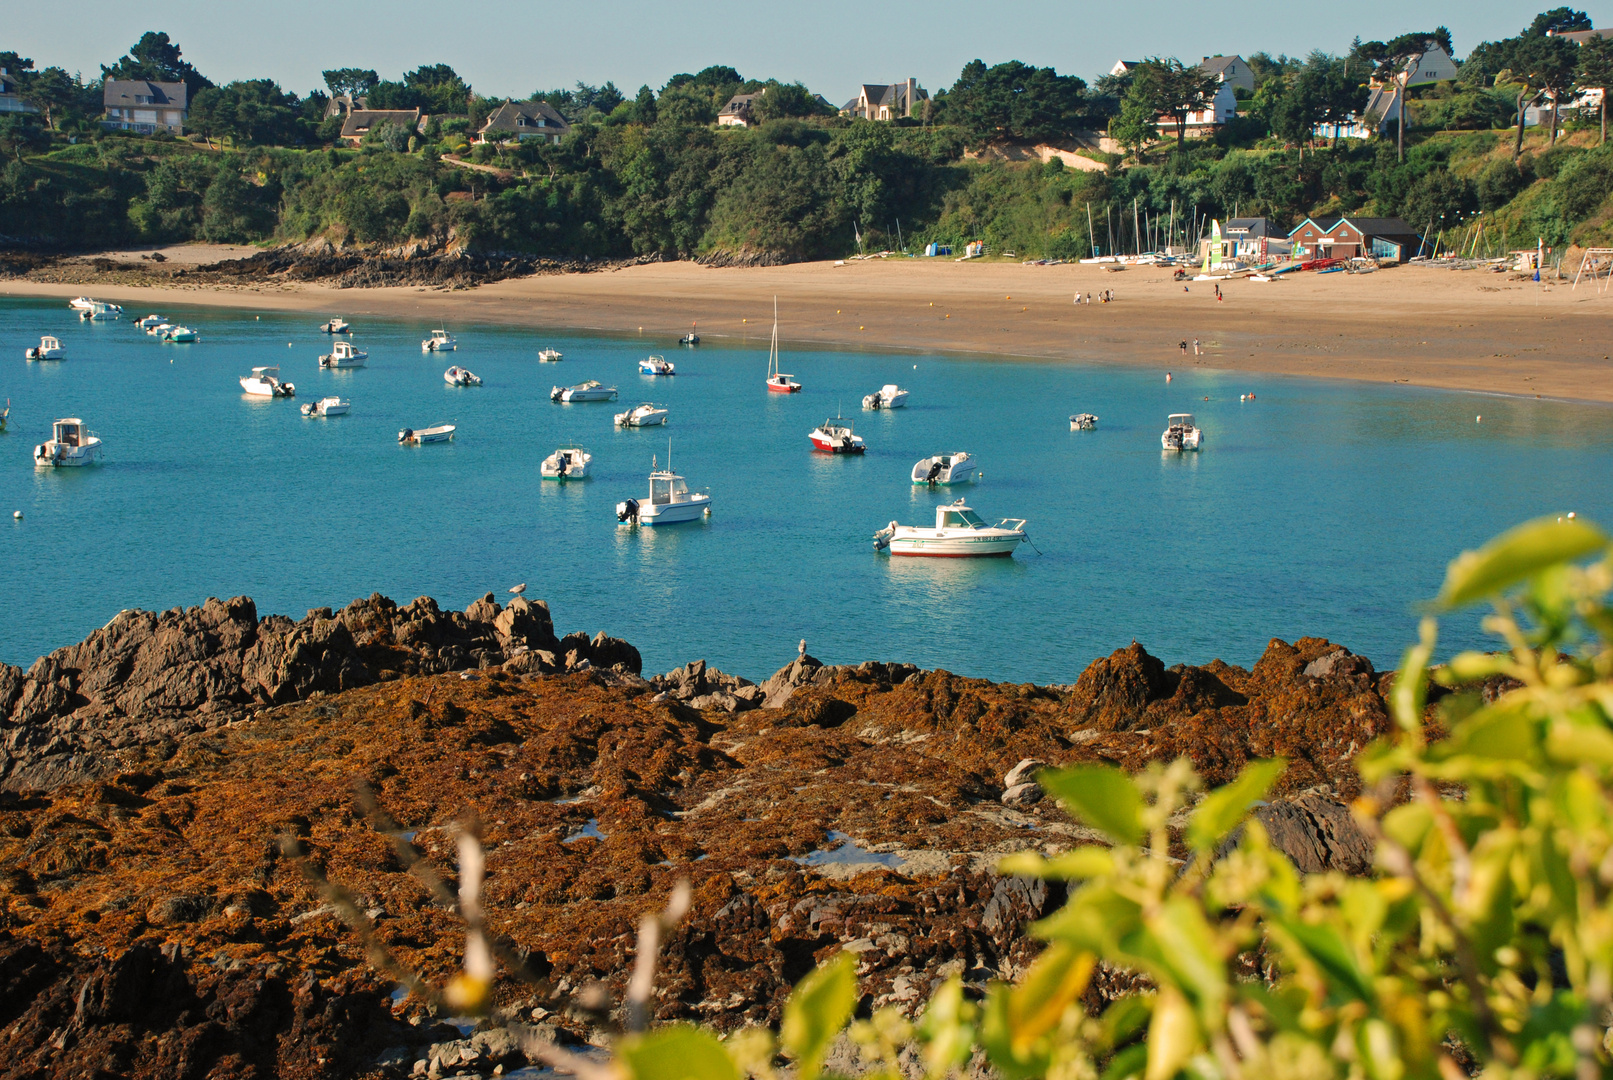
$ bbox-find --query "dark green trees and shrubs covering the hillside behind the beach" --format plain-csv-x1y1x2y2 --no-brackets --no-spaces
0,8,1613,261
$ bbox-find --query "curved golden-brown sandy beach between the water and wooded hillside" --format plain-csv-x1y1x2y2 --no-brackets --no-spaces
0,247,1613,403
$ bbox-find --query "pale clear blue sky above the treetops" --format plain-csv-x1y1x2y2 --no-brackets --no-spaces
0,0,1613,102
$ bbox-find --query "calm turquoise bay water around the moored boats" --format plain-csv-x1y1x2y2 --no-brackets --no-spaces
0,300,1613,682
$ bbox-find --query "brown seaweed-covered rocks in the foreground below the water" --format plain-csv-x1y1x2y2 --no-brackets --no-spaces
0,595,1392,1078
